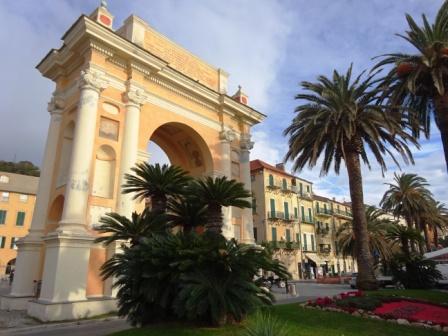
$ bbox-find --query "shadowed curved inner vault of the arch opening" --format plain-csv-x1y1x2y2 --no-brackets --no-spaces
148,122,213,177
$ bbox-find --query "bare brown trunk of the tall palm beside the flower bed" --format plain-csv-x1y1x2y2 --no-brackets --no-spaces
345,151,378,290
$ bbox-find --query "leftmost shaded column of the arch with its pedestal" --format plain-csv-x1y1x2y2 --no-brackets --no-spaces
11,93,64,296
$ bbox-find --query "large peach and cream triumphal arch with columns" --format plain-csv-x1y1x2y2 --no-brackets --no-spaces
1,4,264,321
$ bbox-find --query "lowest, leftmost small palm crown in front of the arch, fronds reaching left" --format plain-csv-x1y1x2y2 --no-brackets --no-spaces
95,211,167,246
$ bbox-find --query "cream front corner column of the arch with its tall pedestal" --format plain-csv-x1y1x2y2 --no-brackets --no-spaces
39,69,107,303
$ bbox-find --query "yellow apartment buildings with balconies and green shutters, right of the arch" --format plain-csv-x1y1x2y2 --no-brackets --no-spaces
250,160,356,279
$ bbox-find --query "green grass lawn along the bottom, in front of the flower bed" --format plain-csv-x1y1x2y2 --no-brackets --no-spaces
108,303,445,336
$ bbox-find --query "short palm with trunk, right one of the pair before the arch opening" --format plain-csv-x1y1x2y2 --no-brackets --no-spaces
189,176,252,234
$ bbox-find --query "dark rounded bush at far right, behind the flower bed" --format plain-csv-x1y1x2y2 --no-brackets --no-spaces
390,254,442,289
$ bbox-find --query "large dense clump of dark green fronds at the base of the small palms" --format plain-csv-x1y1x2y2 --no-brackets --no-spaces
103,232,289,325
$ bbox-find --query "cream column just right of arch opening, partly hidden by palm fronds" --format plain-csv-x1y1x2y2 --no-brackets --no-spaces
219,130,235,239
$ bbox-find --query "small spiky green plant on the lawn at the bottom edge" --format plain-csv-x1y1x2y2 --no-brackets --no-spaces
243,311,288,336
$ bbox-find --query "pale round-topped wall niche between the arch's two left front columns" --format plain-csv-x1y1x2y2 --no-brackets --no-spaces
92,145,116,198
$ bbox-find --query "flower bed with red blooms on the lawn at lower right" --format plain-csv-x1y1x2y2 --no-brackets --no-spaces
305,291,448,332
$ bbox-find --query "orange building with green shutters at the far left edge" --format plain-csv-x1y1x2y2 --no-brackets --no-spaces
0,172,39,276
